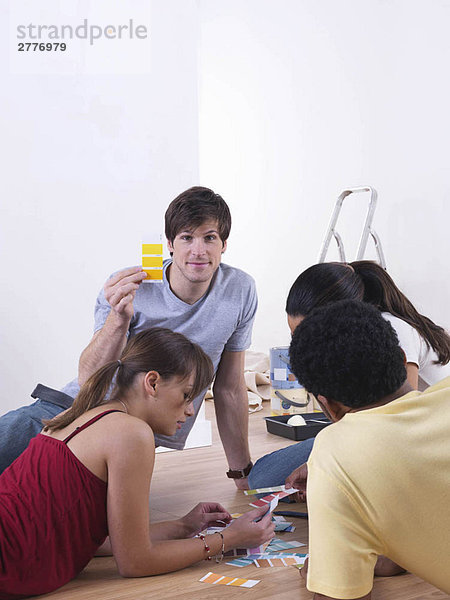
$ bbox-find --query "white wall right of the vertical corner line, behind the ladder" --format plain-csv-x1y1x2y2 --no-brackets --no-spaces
200,0,450,351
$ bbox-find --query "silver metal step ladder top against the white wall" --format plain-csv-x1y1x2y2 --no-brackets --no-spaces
318,185,386,269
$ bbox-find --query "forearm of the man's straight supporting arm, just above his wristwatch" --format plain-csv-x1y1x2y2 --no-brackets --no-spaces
214,386,250,469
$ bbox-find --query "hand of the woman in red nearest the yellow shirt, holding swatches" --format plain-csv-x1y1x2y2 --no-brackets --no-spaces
223,506,275,550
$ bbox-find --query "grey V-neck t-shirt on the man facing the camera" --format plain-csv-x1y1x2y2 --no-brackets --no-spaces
62,260,258,449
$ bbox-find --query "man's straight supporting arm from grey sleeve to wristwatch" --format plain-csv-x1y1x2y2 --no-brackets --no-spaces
213,351,250,489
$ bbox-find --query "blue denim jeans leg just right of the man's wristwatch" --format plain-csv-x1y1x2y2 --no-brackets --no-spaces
248,438,314,489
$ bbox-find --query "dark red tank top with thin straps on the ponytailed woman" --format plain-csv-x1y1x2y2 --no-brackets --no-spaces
0,410,122,600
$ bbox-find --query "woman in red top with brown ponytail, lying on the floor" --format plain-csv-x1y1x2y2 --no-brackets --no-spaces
0,328,274,600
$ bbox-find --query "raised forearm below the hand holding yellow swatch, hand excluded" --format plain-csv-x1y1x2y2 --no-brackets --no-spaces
78,311,129,385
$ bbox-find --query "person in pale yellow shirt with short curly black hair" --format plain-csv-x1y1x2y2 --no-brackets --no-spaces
286,301,450,600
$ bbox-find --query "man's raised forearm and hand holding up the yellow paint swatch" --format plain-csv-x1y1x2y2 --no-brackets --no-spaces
78,267,145,385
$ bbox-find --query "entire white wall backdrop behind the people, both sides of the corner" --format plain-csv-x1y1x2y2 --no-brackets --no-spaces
0,0,450,412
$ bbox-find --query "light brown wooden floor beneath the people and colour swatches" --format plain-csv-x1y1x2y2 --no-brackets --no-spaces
40,402,450,600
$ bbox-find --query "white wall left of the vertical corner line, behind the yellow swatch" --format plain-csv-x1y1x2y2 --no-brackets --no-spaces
0,0,198,413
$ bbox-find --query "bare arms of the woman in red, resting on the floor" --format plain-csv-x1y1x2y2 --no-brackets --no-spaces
107,425,274,577
